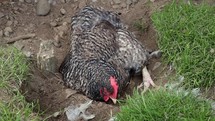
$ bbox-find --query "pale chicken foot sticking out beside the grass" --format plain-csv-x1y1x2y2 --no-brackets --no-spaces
137,66,157,93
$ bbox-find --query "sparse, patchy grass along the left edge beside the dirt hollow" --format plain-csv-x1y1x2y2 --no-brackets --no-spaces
0,47,38,121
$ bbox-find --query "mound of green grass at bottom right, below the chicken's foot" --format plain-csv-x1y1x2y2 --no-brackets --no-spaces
116,89,215,121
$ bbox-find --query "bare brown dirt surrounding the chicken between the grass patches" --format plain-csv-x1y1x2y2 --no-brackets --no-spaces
0,0,213,121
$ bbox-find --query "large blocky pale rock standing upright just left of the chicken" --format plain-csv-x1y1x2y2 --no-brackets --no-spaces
37,40,57,74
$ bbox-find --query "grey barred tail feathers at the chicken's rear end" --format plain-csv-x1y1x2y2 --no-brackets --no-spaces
72,6,123,32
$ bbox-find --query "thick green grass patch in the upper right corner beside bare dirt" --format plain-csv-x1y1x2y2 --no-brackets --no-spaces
151,1,215,87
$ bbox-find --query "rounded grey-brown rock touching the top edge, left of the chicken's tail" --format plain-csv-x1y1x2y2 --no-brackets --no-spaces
36,0,51,16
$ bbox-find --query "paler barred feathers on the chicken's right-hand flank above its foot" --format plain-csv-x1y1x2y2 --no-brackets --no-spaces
113,29,150,74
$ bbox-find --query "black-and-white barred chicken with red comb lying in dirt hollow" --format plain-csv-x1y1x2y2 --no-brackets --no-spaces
60,6,160,102
